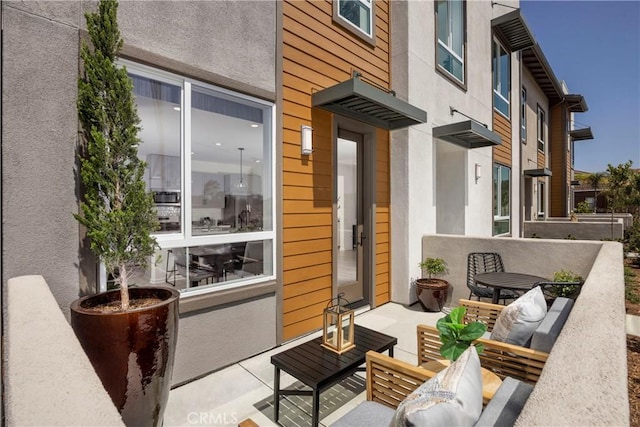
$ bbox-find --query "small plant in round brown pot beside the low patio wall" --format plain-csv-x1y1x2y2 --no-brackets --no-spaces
416,258,449,311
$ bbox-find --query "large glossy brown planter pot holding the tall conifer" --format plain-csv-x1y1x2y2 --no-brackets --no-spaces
71,287,180,426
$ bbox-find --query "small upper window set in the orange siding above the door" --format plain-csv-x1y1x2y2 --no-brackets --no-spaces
333,0,375,44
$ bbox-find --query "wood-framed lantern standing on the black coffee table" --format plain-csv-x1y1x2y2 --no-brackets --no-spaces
322,293,356,354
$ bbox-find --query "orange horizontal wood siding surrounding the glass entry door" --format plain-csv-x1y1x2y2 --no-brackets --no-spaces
282,0,390,340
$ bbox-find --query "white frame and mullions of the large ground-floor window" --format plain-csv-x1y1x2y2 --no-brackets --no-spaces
118,58,278,297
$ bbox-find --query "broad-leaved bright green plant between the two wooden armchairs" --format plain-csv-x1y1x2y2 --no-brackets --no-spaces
436,307,487,361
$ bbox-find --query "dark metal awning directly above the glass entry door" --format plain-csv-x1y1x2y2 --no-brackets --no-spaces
311,75,427,130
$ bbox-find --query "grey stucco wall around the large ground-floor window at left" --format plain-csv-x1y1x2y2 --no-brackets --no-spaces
2,0,277,388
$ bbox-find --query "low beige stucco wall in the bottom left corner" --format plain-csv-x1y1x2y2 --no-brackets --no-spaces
2,276,124,426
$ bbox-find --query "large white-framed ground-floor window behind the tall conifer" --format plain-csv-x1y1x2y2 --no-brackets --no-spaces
123,61,275,292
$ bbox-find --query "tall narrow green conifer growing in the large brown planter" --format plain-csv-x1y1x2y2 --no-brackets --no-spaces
74,0,159,310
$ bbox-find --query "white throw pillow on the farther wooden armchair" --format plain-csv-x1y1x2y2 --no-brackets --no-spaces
491,286,547,346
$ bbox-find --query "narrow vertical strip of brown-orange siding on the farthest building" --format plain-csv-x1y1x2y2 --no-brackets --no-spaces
548,105,567,217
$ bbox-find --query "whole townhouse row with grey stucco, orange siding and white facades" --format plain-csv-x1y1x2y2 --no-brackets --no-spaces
2,0,586,384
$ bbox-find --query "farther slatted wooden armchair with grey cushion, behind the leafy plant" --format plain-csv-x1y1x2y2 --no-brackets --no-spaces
418,297,573,384
